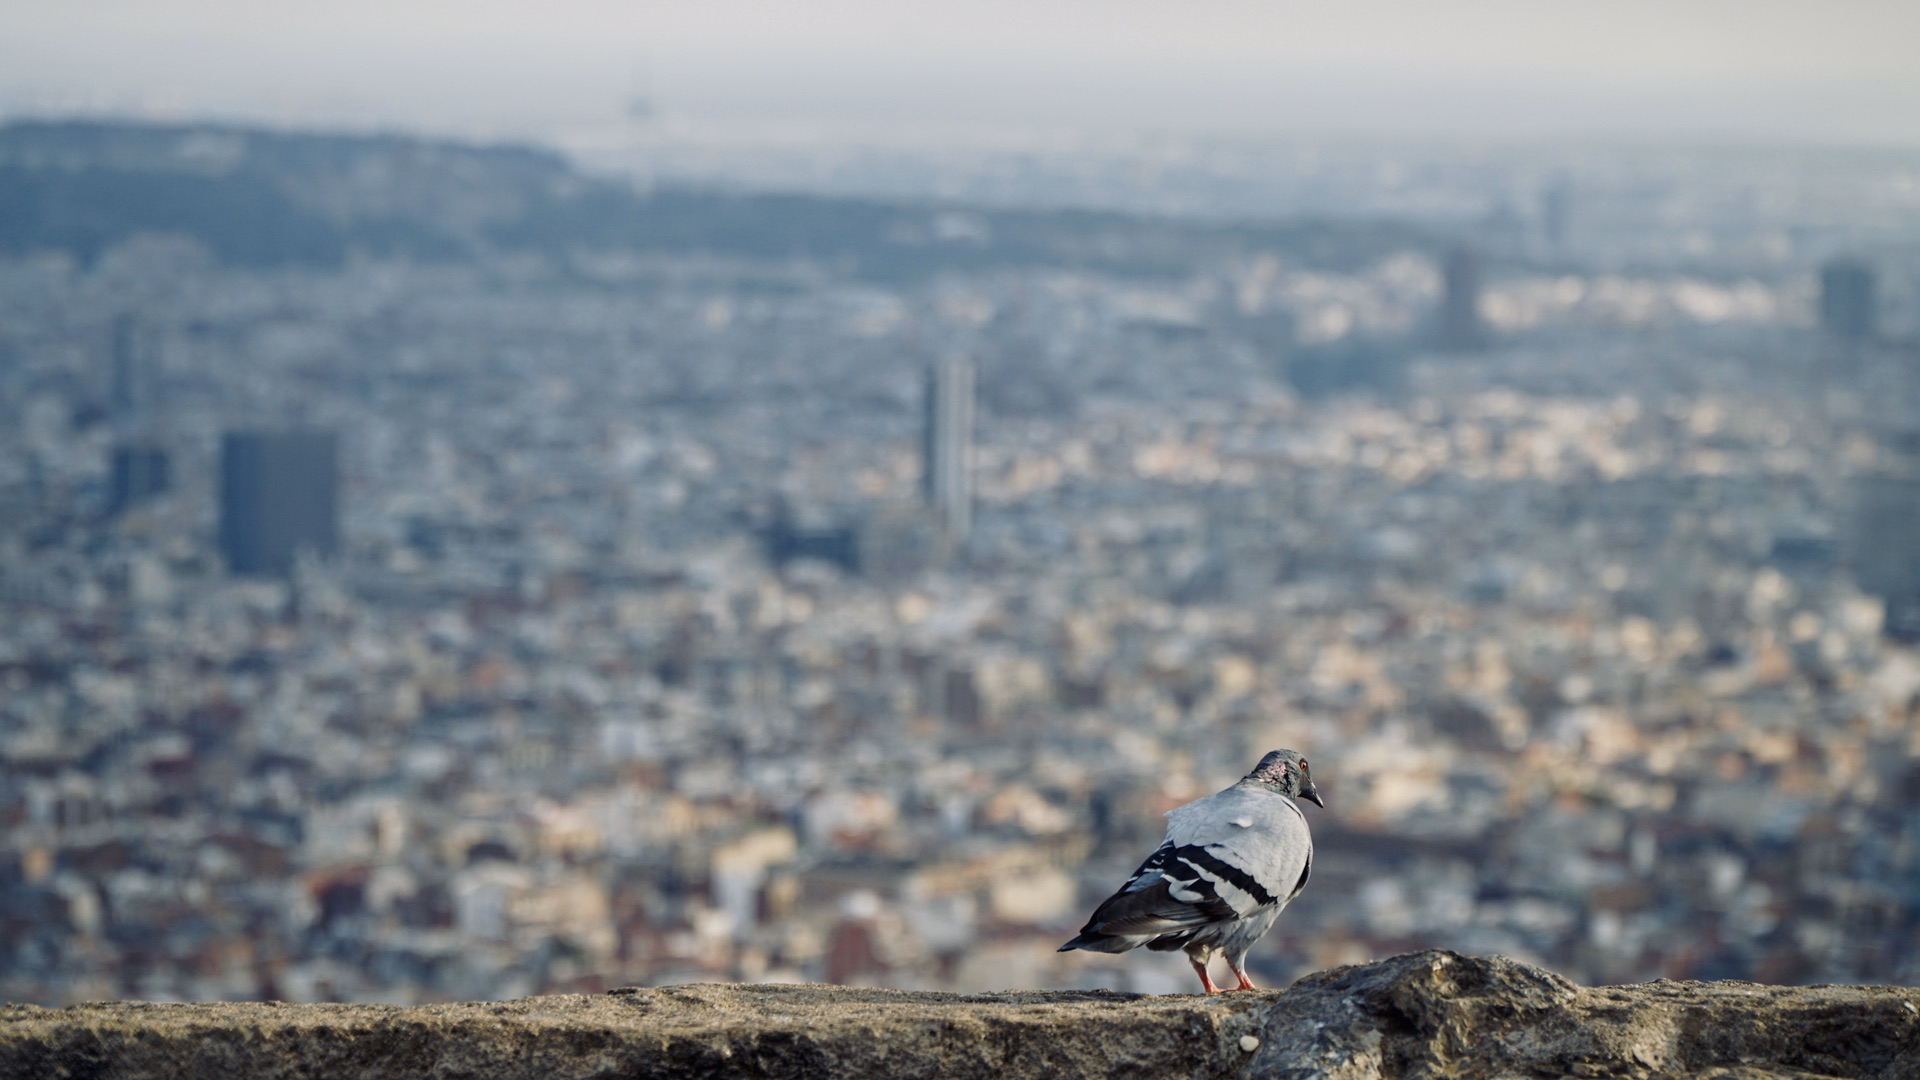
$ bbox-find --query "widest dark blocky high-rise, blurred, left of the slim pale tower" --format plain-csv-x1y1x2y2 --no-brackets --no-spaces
221,430,340,575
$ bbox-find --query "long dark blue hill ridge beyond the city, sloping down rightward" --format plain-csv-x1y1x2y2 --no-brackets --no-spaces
0,121,1430,281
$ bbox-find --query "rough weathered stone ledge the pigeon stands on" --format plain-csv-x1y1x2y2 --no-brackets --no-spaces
11,951,1920,1080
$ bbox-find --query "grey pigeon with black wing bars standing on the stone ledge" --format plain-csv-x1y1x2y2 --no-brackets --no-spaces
1060,749,1327,994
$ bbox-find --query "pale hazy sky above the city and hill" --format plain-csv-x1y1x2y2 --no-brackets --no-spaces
0,0,1920,144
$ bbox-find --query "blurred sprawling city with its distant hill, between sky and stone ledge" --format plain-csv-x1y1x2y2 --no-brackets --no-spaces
0,123,1920,1003
